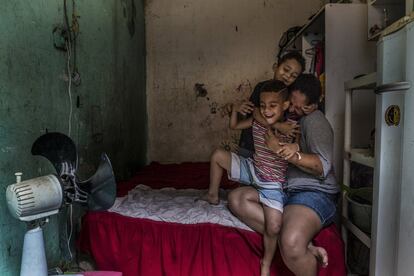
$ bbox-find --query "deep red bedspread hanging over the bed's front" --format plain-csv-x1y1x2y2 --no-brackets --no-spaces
79,163,346,276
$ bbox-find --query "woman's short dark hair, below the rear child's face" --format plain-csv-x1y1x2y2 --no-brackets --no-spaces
289,74,321,104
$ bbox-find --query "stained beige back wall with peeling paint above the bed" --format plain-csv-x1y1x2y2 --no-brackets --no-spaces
145,0,323,162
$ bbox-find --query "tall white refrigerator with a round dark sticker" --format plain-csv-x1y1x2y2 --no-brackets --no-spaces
370,18,414,276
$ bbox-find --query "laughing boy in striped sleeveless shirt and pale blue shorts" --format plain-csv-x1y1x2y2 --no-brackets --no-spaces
203,80,296,276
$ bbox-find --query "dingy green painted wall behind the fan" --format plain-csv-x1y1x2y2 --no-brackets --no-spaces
0,0,147,276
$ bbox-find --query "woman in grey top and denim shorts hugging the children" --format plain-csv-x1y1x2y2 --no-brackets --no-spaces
229,74,339,276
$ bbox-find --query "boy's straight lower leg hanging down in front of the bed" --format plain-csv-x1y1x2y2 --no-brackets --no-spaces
260,205,282,276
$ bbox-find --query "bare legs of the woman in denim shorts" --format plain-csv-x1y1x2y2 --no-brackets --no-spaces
228,187,328,275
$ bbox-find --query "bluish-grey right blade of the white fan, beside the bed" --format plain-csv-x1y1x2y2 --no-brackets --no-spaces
78,153,116,211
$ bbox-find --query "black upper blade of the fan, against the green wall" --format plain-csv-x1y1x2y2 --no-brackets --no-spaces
32,132,78,175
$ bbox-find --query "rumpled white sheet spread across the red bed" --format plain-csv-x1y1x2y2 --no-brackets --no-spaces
109,184,253,231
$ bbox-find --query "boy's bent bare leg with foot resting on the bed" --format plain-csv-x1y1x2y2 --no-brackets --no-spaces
200,149,231,205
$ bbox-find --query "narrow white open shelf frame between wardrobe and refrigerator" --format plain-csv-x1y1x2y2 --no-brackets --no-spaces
342,73,377,274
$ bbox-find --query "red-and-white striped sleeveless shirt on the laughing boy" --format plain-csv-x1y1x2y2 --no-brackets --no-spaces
252,120,292,184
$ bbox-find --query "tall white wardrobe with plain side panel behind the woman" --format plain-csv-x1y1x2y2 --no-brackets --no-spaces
283,3,376,183
